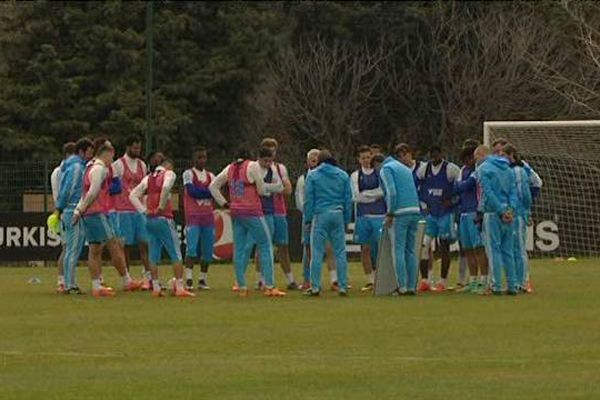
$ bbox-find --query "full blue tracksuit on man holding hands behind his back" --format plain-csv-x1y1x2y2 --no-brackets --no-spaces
476,156,517,291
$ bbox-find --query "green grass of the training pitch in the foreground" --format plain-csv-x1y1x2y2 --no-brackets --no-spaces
0,260,600,400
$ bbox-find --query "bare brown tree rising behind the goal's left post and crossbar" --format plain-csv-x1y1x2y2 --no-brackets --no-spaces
429,2,557,148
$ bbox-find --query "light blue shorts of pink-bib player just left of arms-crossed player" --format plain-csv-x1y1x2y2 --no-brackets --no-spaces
146,217,183,265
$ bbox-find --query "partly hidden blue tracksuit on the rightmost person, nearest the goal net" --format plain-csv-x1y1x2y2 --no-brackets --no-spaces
512,165,533,286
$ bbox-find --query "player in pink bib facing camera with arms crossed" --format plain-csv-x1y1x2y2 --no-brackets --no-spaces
183,147,215,290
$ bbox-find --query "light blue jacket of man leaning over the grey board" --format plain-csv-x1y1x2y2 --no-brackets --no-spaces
379,156,421,215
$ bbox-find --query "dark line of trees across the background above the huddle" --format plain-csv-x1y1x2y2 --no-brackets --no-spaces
0,1,600,172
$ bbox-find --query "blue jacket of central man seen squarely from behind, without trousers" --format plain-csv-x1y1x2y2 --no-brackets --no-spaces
304,162,352,224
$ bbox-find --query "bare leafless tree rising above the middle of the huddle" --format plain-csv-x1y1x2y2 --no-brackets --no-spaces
270,39,390,165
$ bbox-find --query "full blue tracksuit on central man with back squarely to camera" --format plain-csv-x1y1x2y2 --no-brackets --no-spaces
304,161,352,292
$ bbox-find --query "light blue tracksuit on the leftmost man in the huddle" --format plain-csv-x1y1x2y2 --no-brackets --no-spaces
56,155,86,289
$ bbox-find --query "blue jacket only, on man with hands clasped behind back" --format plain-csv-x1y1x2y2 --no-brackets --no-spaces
476,155,518,216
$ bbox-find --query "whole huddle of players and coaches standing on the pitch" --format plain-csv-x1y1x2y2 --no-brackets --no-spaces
49,136,541,297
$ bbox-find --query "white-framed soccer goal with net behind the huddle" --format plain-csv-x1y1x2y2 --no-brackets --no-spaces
483,121,600,257
